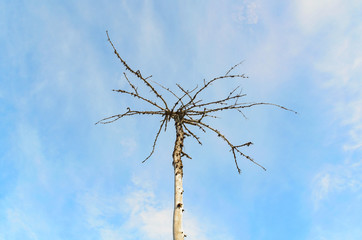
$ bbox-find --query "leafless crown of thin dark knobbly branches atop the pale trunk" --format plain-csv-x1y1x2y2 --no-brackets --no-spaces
96,31,297,173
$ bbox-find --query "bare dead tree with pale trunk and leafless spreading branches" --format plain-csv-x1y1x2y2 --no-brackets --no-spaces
96,32,296,240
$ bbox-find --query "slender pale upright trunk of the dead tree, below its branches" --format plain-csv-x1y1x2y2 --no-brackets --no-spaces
172,119,185,240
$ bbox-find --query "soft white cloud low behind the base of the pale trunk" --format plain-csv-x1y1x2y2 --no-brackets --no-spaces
78,174,232,240
